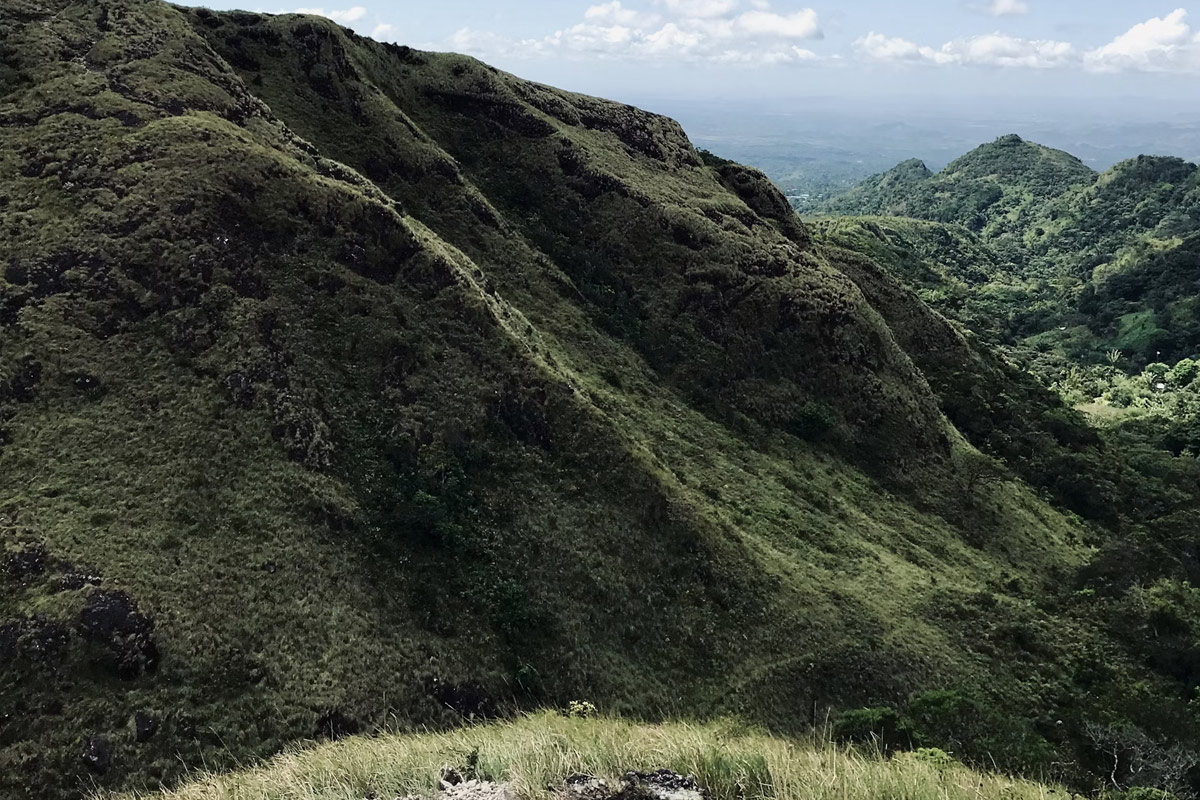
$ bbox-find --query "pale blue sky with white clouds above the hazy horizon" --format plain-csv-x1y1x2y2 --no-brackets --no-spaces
194,0,1200,106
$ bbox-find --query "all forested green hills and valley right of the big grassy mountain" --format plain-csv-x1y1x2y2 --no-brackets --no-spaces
814,138,1200,794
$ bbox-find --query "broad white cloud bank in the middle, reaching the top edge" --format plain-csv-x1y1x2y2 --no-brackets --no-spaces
449,0,822,65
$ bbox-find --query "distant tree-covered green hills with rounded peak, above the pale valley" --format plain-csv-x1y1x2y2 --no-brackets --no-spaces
824,137,1200,368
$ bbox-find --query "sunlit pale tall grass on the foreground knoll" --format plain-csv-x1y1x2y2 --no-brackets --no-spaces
110,712,1064,800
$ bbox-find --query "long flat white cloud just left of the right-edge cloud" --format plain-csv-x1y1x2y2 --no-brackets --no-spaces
854,32,1079,70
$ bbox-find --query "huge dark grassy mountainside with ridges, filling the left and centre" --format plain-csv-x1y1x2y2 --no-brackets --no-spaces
0,0,1190,798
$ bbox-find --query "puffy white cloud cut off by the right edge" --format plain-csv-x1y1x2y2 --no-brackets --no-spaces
1084,8,1200,72
